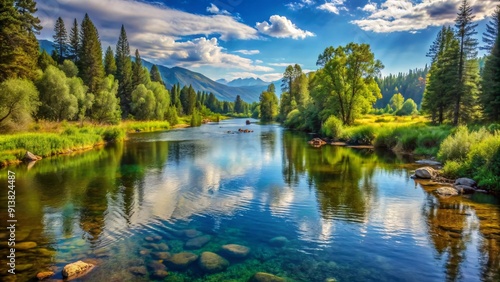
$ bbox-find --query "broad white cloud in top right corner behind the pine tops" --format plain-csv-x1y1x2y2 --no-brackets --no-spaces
351,0,498,33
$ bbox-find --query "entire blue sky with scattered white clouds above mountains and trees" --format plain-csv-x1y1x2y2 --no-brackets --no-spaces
36,0,500,81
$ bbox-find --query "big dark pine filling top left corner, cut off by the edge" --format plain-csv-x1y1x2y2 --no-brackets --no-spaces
0,0,42,82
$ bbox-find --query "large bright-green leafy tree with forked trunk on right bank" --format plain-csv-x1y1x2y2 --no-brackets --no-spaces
311,43,383,124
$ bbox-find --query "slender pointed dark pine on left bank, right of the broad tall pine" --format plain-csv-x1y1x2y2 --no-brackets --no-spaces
115,25,134,118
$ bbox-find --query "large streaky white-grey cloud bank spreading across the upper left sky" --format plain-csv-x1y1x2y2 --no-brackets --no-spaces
37,0,273,71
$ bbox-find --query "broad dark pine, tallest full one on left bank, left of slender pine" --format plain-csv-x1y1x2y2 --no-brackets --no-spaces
78,14,104,93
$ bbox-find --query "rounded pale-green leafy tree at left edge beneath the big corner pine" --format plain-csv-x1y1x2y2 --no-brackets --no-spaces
0,79,40,126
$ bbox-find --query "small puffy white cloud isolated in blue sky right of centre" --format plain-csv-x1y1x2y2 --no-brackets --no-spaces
255,15,314,39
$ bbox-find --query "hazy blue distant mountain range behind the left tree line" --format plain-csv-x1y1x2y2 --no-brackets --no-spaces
39,40,281,103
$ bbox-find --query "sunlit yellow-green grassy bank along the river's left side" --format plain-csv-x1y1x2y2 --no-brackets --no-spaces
0,121,176,167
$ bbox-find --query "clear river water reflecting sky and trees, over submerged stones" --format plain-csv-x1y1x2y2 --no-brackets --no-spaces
0,120,500,281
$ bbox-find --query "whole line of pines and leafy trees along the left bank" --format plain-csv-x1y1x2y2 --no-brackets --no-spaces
0,0,252,132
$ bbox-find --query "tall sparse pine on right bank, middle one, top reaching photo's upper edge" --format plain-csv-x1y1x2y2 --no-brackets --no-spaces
453,0,478,125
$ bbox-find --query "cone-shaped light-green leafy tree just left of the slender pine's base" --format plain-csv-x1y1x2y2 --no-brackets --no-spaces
91,75,121,124
